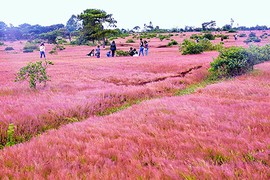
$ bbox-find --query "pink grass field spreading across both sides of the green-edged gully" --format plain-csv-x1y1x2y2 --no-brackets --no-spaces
0,31,270,179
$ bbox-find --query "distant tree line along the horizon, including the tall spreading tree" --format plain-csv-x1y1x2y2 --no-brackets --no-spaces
0,9,270,44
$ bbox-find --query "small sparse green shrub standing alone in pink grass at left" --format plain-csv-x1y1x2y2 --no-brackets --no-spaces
15,61,53,89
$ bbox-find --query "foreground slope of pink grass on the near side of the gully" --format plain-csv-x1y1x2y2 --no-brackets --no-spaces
0,63,270,179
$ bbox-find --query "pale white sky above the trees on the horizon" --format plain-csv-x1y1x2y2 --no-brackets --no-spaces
0,0,270,29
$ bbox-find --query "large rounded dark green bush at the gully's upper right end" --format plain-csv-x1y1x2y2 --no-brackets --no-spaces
209,47,254,79
